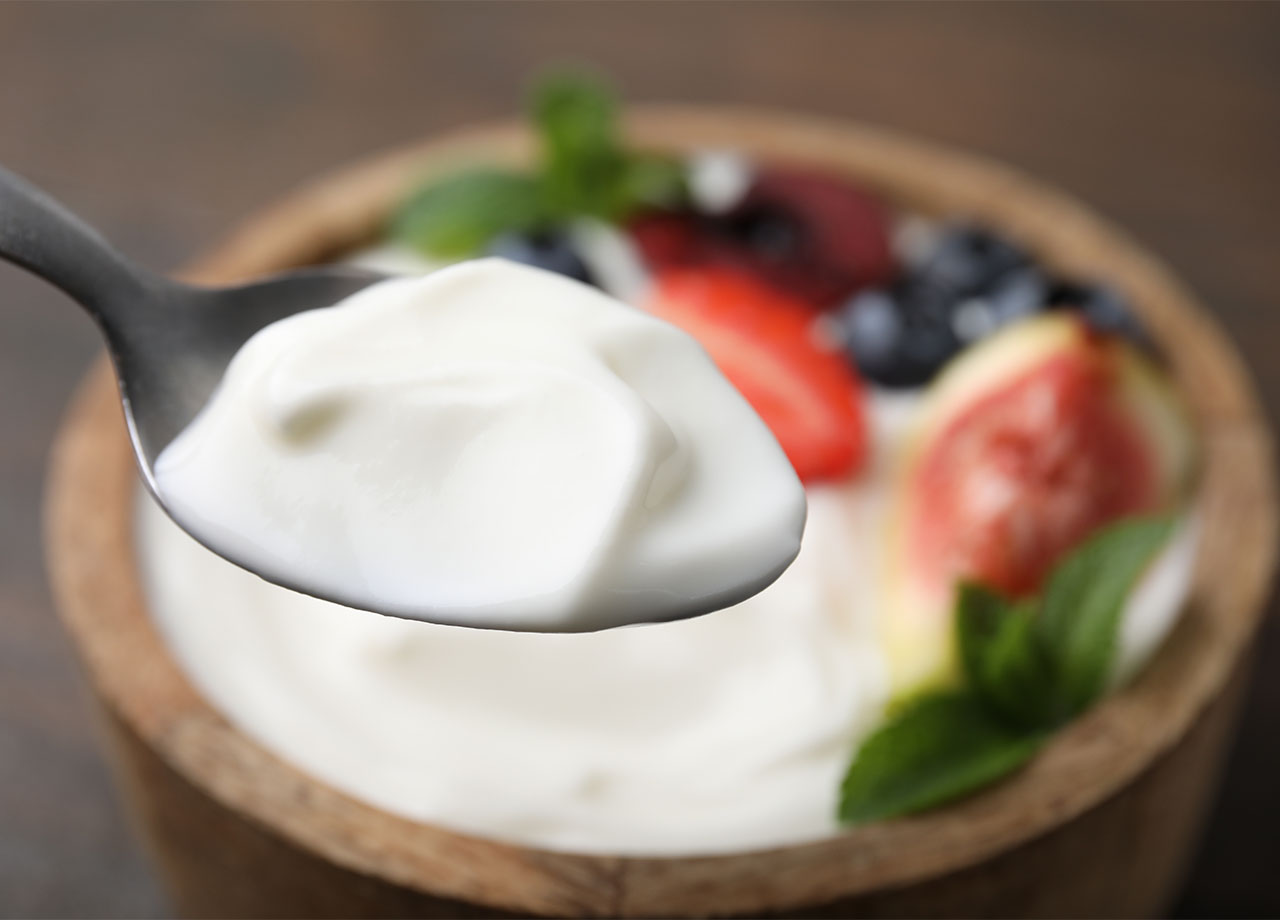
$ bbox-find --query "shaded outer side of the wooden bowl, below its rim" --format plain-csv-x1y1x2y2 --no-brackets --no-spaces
94,655,1244,920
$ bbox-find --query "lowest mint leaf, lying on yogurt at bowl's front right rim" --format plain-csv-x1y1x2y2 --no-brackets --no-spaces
840,692,1044,823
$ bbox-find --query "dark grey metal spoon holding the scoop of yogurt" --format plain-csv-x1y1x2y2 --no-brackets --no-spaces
0,168,384,594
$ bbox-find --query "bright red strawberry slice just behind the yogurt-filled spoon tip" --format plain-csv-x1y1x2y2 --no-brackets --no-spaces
648,267,867,482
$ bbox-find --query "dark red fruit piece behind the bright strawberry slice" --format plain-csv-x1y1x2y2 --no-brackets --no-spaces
631,168,893,307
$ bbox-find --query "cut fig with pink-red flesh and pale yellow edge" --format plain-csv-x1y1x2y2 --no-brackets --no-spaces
886,313,1193,688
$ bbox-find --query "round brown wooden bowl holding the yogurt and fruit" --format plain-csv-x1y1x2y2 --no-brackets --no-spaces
47,107,1276,916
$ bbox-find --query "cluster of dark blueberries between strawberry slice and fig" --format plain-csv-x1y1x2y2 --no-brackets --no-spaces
838,224,1048,388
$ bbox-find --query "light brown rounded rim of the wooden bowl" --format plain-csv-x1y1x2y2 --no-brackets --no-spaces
45,105,1277,916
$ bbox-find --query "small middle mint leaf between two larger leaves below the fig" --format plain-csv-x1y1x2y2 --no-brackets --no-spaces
955,582,1062,729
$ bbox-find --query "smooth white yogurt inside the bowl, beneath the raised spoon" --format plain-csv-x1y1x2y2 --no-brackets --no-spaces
137,381,1197,855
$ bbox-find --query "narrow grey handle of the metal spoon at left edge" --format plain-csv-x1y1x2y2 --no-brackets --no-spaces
0,166,157,335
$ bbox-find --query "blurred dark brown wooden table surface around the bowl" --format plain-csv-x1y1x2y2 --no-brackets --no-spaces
0,4,1280,916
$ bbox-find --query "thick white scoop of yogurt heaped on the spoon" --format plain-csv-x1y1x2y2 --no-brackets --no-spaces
155,260,805,631
